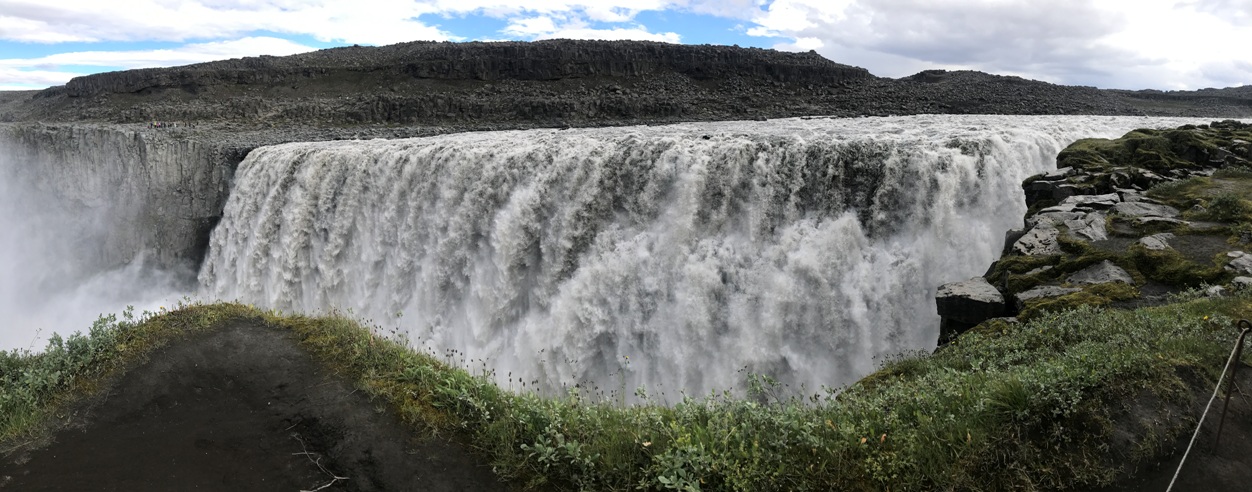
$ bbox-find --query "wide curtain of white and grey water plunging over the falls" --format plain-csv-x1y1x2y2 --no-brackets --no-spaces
200,116,1202,398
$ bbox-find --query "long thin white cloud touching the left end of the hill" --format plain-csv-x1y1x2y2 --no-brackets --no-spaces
0,38,313,89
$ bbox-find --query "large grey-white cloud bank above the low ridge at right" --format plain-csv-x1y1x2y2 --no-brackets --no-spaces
747,0,1252,89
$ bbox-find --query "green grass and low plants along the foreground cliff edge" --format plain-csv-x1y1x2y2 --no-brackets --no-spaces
0,294,1252,491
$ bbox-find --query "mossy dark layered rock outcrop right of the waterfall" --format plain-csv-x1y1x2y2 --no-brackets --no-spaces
936,120,1252,344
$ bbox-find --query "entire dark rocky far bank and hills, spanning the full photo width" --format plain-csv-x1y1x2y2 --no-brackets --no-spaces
0,40,1252,130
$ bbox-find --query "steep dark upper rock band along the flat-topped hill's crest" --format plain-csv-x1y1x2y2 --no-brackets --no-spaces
58,40,873,98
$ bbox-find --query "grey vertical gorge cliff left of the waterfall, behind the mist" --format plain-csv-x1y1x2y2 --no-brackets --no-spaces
0,124,243,269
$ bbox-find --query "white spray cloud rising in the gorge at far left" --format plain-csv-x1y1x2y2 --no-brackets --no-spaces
0,132,189,352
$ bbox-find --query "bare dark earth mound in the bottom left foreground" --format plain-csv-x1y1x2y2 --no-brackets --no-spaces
0,323,507,491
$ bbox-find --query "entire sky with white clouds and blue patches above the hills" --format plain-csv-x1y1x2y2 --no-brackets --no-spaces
0,0,1252,89
